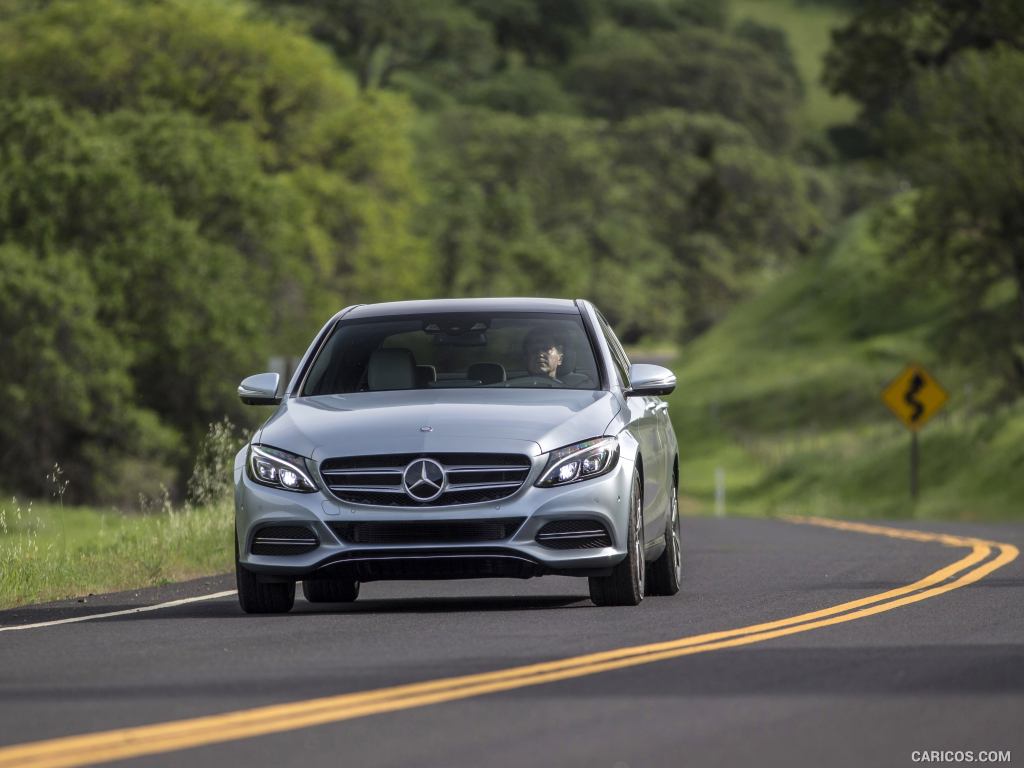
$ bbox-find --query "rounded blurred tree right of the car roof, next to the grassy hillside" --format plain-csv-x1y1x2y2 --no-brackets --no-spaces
614,110,835,336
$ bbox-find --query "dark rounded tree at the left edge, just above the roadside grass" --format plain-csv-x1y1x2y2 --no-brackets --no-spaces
0,244,177,501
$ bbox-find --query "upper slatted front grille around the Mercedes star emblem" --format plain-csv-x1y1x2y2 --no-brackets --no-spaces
321,454,530,507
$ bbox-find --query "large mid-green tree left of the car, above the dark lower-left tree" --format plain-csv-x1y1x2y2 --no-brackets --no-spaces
0,99,303,430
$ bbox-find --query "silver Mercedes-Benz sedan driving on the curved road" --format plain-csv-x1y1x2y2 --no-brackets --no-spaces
234,299,681,613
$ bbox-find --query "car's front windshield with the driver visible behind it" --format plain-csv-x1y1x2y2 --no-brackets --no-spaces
301,312,600,396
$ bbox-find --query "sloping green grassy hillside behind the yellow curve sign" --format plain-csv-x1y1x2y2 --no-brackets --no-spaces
672,214,1024,519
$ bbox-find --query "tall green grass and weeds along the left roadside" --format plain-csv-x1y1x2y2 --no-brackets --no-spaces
0,422,241,608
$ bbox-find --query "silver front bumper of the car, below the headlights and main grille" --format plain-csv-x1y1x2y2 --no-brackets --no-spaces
234,457,633,582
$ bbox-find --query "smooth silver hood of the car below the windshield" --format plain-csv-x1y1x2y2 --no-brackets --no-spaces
254,388,622,461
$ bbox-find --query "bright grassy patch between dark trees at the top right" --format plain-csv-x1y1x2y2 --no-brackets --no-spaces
732,0,857,132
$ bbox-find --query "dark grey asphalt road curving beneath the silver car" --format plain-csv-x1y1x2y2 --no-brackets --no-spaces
0,519,1024,768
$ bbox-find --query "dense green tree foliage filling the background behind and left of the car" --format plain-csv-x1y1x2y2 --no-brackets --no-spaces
0,0,837,503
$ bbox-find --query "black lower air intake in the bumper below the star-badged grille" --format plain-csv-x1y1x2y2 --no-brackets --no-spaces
329,517,526,544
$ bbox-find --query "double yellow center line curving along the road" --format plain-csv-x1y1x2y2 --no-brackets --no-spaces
0,517,1019,768
